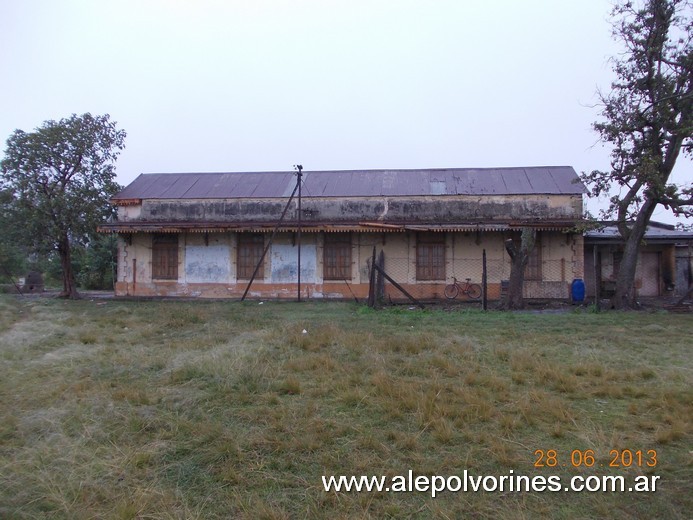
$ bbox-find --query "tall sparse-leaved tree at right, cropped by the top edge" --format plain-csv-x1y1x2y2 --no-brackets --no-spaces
582,0,693,308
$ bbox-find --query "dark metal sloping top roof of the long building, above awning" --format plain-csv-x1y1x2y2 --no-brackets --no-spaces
113,166,586,201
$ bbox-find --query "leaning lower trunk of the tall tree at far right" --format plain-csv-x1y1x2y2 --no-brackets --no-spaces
611,200,656,309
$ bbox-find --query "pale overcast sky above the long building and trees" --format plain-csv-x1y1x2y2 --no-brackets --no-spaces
0,0,693,222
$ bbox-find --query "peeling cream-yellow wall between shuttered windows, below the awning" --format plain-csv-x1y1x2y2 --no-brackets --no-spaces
116,232,583,299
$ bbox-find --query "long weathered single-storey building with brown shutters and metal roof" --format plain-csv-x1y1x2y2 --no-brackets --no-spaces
99,166,585,301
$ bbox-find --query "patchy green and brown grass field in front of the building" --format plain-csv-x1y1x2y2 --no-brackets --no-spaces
0,296,693,519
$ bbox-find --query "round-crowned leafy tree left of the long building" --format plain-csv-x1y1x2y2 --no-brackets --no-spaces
0,113,125,298
